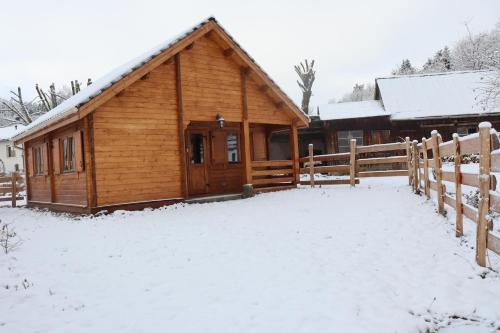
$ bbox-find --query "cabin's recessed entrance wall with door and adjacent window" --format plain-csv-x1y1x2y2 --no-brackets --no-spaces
186,125,243,196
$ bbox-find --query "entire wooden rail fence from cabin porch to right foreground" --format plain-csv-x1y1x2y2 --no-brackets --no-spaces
300,123,500,266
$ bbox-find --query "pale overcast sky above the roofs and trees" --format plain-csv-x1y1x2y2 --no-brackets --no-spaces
0,0,500,105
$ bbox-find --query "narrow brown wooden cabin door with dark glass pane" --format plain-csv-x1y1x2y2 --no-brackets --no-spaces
186,130,208,195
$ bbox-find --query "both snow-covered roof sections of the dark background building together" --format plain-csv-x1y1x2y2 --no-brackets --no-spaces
319,70,500,120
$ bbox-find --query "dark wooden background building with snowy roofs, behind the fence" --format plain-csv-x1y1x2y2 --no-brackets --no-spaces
299,70,500,155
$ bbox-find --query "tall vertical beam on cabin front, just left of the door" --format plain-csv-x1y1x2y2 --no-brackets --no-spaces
175,52,189,198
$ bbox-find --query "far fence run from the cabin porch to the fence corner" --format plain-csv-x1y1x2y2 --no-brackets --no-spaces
300,139,410,187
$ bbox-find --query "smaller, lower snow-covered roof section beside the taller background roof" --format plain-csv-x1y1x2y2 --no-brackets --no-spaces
319,100,389,120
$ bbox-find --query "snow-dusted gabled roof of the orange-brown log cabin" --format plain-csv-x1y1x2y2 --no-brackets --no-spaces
14,17,307,139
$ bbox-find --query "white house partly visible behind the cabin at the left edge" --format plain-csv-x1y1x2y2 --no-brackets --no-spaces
0,125,24,174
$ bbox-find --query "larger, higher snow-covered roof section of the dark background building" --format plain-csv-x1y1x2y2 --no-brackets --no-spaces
376,71,500,120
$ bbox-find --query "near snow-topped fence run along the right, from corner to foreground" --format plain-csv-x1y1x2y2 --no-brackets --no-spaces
407,122,500,266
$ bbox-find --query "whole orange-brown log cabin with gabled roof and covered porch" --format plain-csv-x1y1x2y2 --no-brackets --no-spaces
14,17,309,213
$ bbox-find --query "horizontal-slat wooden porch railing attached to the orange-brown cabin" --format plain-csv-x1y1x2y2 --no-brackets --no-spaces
252,160,294,192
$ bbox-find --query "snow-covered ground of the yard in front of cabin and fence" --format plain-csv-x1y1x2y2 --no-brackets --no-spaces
0,177,500,333
